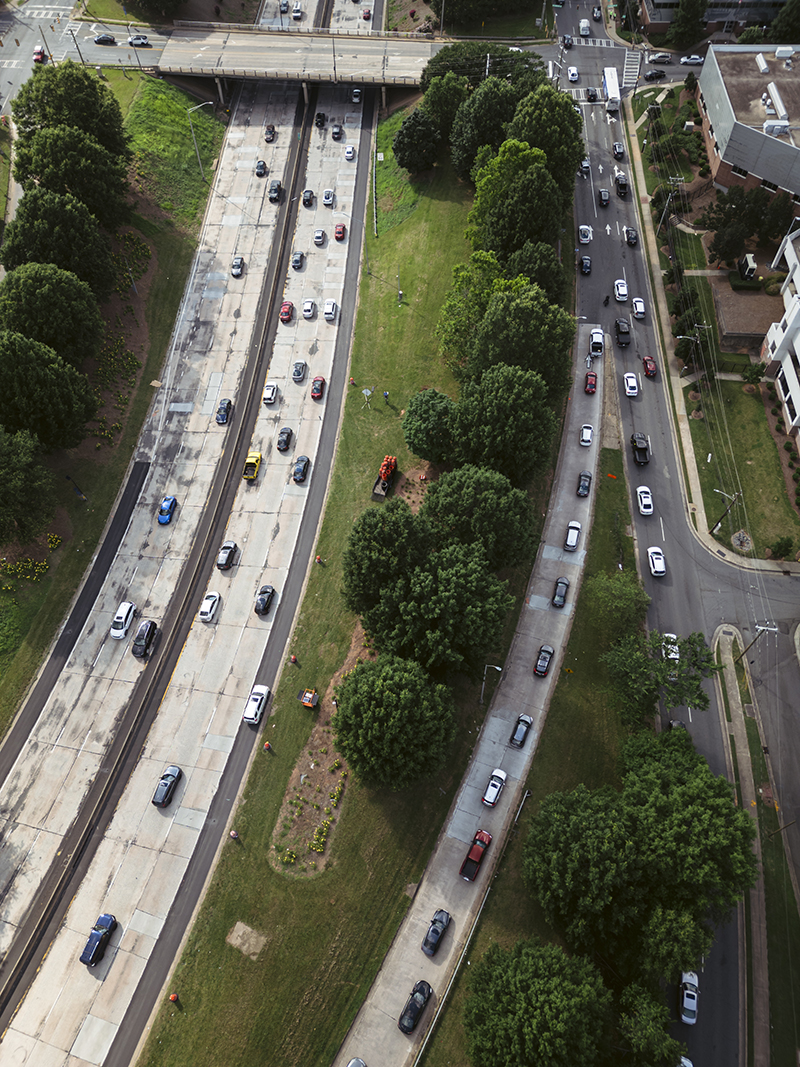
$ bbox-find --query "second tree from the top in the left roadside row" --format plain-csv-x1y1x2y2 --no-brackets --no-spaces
14,126,129,229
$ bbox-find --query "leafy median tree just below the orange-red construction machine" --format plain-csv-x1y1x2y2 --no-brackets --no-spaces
342,497,433,615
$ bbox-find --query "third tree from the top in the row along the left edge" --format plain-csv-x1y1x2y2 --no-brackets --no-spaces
0,189,116,302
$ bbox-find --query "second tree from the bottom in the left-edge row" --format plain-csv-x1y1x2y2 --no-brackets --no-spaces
0,331,97,450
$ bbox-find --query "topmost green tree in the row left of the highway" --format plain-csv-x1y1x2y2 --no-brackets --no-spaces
11,58,130,159
